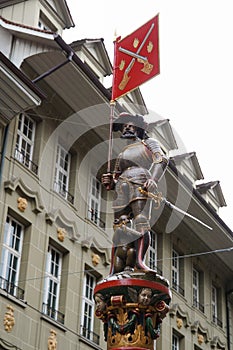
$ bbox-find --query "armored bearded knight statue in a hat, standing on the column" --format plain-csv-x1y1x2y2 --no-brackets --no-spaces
102,113,168,274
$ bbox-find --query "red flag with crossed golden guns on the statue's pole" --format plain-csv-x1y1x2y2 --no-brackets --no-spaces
112,15,159,100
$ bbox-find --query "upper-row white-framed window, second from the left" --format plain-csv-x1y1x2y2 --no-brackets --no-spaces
54,145,73,204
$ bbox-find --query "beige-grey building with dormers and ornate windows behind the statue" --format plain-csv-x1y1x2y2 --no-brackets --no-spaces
0,0,233,350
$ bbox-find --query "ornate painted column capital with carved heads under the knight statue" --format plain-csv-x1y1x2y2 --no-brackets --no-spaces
94,270,171,350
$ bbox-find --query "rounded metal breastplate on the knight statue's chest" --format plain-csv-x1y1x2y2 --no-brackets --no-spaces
119,142,153,172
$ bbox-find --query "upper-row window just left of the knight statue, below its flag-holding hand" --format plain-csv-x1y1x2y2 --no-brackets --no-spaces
88,175,105,228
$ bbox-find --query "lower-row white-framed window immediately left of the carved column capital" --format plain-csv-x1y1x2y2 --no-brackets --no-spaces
81,272,99,344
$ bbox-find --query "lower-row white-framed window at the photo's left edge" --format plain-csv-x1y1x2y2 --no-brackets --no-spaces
0,216,24,299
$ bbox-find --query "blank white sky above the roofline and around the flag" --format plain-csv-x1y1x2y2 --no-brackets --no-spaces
63,0,233,230
